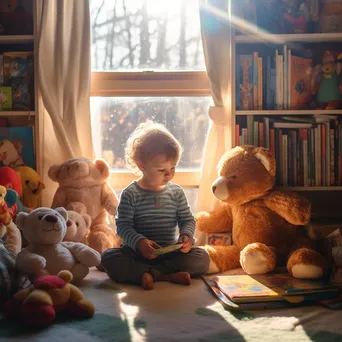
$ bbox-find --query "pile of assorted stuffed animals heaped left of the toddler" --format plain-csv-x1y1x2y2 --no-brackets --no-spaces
0,158,121,325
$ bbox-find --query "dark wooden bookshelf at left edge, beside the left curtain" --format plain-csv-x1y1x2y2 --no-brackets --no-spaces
0,0,41,173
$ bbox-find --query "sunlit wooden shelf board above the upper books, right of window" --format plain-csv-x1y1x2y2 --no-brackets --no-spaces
234,31,342,44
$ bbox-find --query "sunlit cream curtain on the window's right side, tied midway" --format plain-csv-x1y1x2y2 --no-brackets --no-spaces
196,0,233,245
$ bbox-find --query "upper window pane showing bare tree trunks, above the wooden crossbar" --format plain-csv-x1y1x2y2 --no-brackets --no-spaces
90,0,205,71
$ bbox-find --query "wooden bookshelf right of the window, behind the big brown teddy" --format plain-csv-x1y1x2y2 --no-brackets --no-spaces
229,0,342,218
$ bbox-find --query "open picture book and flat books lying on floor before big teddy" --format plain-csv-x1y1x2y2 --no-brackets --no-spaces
203,273,342,310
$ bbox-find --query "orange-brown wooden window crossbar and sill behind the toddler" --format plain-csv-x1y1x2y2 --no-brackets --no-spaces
90,70,211,189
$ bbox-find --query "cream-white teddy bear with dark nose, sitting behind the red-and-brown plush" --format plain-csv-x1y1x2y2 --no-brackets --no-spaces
16,207,100,282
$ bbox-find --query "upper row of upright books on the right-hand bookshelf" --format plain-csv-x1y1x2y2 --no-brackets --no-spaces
236,45,342,110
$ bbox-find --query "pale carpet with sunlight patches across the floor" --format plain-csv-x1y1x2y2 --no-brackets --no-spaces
0,270,342,342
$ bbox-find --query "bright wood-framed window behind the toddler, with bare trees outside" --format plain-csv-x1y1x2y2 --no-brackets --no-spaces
90,0,210,206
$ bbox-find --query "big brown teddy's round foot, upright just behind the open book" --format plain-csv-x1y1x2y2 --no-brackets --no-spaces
240,243,276,274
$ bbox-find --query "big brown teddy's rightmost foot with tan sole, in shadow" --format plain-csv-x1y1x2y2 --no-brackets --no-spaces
287,248,328,279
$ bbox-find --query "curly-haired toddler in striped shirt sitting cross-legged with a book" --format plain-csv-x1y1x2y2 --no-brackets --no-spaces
102,122,209,290
